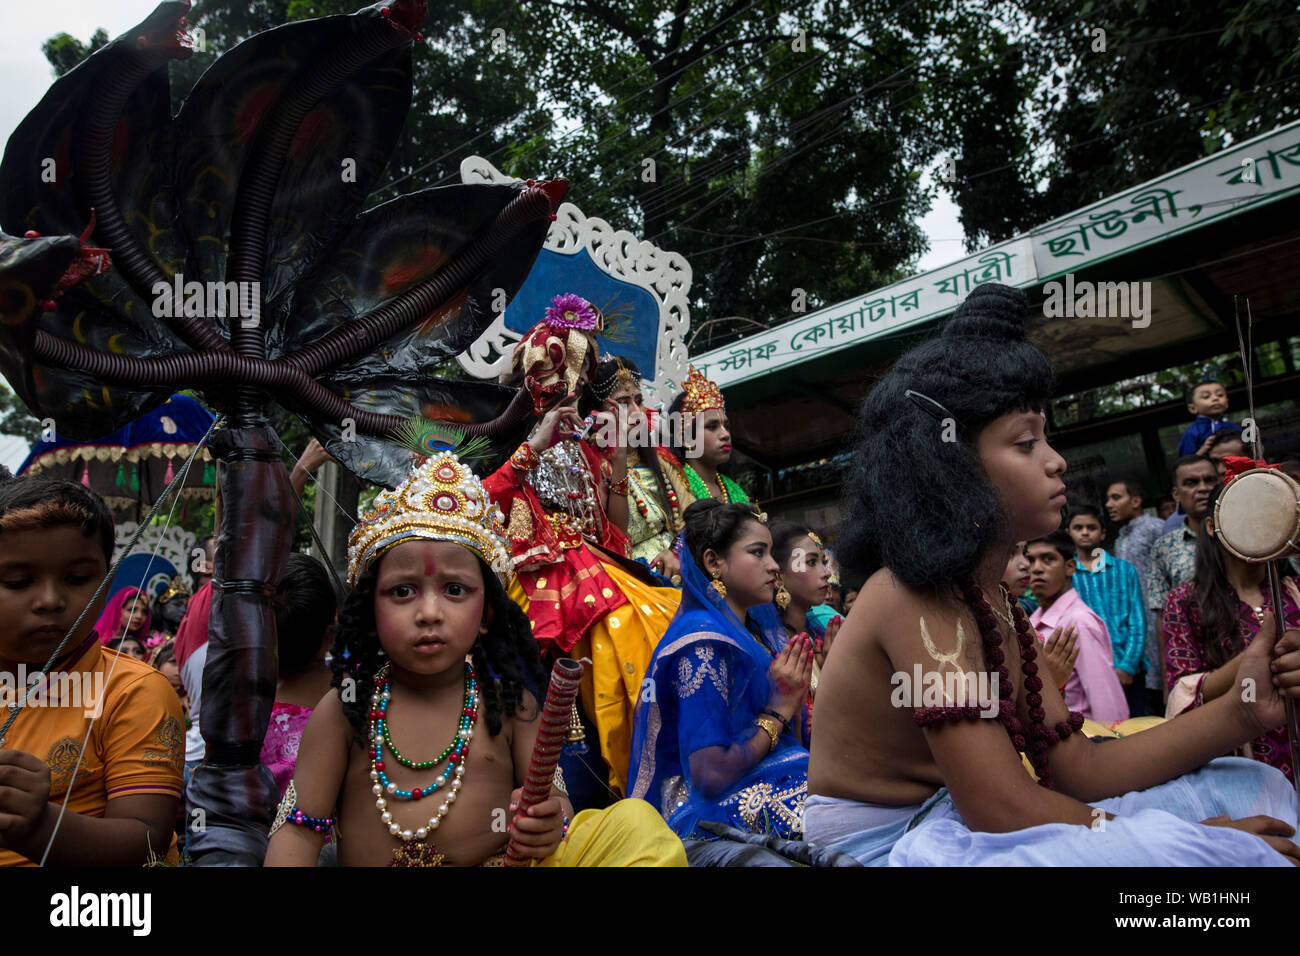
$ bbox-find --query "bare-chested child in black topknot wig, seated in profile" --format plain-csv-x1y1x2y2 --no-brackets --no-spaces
803,285,1300,866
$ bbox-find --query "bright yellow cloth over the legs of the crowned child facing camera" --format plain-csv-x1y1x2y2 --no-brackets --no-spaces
533,800,686,866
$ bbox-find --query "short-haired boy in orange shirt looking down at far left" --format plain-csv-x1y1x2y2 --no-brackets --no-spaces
0,477,185,866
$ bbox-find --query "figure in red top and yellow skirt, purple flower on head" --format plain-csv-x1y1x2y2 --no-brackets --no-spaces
484,295,680,804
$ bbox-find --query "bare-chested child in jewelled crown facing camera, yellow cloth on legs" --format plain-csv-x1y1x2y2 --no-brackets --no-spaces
267,453,685,866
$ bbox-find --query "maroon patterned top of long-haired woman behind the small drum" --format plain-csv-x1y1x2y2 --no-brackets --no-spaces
1164,583,1300,778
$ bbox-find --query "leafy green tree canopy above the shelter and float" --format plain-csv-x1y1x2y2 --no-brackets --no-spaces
46,0,1300,356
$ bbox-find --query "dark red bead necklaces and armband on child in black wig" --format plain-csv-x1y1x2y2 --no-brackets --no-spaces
913,579,1083,790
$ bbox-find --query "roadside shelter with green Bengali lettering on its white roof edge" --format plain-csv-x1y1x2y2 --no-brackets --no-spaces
693,121,1300,527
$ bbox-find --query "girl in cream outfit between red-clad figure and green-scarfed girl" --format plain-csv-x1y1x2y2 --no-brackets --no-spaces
579,356,696,580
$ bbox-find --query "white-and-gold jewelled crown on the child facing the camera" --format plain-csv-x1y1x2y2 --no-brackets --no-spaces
347,451,512,585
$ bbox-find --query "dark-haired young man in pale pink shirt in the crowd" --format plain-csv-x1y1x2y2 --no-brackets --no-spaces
1024,531,1128,723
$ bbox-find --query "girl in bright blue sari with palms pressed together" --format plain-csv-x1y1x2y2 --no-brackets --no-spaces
628,499,813,839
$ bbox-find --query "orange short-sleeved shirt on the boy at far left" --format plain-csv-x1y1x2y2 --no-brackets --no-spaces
0,641,185,866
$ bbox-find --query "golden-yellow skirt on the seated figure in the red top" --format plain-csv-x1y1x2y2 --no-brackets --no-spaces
510,562,681,796
